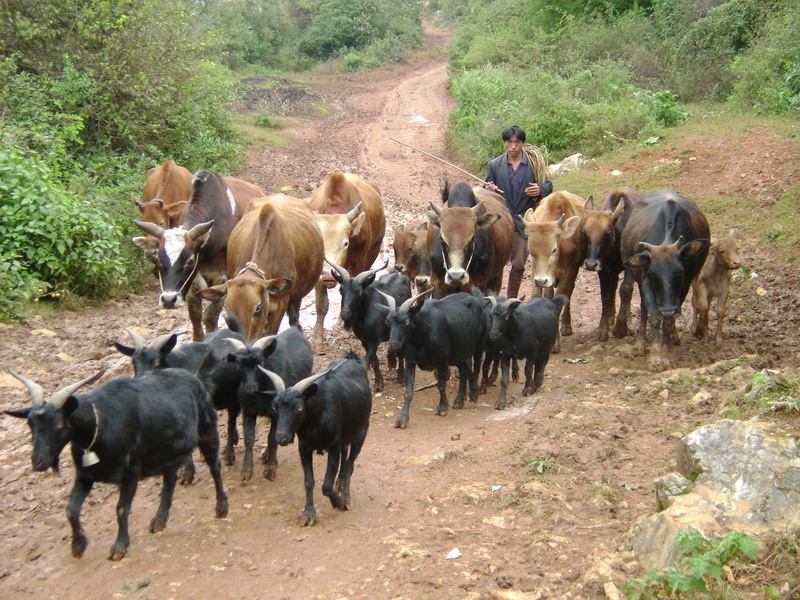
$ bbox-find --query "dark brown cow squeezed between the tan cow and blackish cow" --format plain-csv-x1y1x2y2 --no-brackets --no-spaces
583,187,643,342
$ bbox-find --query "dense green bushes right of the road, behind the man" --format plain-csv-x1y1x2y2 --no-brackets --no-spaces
440,0,800,168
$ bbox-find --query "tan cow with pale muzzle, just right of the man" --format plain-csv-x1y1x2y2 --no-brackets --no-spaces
523,191,586,353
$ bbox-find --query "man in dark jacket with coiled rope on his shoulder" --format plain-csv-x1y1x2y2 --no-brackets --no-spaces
485,125,553,298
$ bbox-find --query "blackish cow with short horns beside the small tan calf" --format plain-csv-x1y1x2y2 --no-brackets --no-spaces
618,190,709,368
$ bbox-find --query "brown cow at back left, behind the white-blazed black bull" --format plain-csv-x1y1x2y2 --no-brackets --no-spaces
133,160,192,229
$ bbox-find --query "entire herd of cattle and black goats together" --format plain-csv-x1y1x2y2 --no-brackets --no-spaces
8,161,739,559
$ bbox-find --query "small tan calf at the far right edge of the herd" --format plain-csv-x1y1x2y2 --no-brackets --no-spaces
692,230,742,346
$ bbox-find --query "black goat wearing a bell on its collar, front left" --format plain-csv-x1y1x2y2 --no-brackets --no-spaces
6,369,228,560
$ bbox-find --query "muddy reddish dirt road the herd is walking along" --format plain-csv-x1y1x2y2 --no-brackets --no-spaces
0,21,797,600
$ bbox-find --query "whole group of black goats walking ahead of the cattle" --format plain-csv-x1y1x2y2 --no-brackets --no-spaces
6,247,567,560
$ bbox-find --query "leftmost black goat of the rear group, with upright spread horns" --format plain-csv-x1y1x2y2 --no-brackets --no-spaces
325,258,411,392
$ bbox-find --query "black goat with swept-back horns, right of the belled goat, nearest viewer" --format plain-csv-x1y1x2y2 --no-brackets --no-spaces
259,353,372,525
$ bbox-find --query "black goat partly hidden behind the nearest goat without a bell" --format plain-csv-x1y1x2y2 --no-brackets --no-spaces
227,327,314,481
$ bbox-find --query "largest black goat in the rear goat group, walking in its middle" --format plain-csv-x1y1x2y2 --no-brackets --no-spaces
386,288,486,429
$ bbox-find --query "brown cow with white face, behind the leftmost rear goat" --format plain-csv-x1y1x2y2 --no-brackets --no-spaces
308,172,386,344
